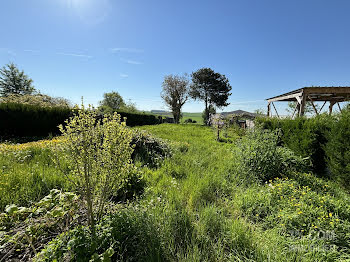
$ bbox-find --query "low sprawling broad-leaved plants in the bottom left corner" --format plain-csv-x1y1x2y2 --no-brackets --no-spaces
0,189,84,261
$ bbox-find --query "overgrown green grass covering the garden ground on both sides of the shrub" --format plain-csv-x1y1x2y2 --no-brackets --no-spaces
0,124,350,261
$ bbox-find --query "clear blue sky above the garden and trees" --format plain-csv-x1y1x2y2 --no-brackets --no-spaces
0,0,350,112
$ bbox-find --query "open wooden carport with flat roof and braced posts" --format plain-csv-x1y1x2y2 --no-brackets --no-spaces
266,86,350,117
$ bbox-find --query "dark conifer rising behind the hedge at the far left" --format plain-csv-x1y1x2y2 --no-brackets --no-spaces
0,63,35,97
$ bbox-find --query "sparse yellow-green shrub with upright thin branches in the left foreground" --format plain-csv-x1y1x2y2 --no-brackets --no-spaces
57,106,134,233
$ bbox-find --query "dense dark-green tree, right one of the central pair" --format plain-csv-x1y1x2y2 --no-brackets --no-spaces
190,68,232,124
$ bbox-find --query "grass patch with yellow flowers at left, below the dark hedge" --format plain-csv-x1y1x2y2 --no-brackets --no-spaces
0,139,71,211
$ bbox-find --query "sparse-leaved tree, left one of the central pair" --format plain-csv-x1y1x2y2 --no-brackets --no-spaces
161,75,189,124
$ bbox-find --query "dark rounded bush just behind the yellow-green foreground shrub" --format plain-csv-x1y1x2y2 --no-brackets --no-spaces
131,129,171,167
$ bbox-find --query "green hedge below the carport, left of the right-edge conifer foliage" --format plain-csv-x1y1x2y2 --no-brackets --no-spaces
256,114,335,174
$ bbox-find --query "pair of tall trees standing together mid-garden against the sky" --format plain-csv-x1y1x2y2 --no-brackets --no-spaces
161,68,232,124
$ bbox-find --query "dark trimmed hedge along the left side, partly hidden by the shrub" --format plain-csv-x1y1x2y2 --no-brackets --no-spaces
0,103,160,140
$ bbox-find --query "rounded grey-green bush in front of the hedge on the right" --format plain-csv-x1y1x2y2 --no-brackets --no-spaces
237,129,307,182
